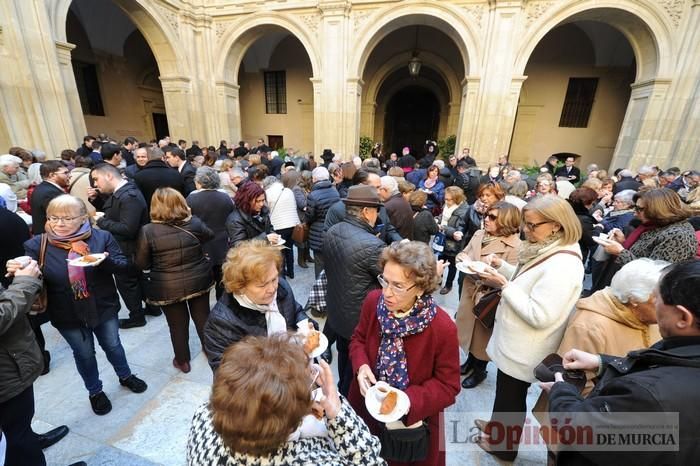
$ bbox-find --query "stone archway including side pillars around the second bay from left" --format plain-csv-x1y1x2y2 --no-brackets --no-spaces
216,13,321,150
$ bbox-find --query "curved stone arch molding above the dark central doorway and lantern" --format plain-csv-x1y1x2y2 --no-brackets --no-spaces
348,1,481,78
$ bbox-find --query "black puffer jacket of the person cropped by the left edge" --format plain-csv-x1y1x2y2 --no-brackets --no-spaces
0,277,44,403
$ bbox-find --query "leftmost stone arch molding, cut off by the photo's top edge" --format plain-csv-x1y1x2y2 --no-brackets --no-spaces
48,0,190,78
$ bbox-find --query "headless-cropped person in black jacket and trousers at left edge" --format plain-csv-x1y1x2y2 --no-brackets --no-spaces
0,261,68,466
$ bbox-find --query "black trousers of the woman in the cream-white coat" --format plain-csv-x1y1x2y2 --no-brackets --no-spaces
486,370,530,461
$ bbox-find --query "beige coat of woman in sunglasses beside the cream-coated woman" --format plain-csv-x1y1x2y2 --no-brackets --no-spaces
455,230,520,361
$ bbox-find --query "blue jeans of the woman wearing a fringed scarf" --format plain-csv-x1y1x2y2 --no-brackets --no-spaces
58,316,131,395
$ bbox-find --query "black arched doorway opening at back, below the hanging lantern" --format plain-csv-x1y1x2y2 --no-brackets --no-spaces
384,86,440,156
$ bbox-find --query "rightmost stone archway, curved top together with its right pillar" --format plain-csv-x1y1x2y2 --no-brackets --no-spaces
514,0,673,168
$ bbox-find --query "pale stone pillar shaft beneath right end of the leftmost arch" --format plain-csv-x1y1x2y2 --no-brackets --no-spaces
160,76,193,140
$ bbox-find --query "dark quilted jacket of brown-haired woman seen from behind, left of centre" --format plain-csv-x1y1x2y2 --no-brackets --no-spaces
136,216,214,306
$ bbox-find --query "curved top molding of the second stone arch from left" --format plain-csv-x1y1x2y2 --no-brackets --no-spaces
216,12,321,85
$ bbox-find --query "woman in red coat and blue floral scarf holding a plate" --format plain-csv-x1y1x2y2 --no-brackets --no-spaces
349,241,459,466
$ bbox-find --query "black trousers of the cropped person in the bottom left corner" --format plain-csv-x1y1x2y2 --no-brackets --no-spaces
0,385,46,466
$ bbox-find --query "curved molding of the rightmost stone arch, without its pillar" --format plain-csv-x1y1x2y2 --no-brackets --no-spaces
514,0,675,82
